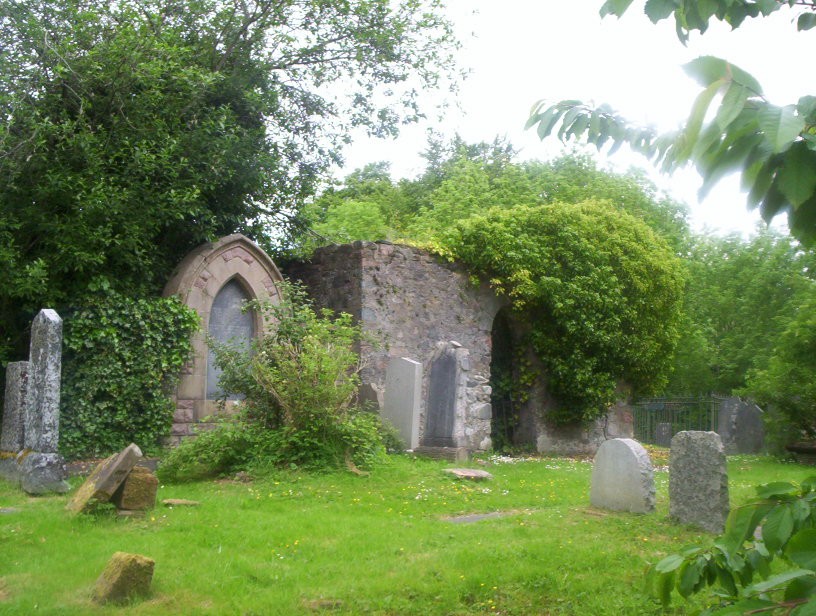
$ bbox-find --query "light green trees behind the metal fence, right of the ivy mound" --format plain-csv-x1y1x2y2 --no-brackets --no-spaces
668,230,814,394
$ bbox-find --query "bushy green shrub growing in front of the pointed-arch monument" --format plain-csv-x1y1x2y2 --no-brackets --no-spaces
161,287,392,480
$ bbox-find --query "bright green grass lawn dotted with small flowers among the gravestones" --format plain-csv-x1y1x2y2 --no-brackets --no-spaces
0,450,813,615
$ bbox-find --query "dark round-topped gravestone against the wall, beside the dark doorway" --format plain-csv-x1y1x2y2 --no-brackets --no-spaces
422,349,457,447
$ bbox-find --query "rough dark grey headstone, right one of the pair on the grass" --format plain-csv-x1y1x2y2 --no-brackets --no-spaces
669,431,729,533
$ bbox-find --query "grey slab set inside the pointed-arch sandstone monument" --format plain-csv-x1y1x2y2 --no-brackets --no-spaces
207,280,255,400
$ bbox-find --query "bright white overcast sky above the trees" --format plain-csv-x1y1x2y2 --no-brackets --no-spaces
338,0,816,234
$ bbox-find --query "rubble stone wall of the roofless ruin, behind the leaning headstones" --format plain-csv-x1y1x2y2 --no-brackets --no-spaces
285,242,502,450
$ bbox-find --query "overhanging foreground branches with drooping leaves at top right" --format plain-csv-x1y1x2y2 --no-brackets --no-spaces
527,0,816,243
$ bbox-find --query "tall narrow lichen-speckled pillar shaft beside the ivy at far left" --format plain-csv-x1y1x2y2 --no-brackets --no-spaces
25,308,62,453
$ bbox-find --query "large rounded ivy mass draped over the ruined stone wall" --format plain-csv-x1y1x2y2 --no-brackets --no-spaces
448,201,684,423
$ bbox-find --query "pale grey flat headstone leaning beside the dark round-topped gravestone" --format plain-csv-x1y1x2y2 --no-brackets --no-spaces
382,357,422,449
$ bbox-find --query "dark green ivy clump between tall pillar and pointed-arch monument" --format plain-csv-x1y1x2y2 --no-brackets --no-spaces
60,293,198,459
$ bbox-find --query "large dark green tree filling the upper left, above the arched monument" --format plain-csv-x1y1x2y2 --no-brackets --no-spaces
0,0,455,358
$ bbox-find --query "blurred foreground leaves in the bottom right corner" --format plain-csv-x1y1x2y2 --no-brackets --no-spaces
650,477,816,616
